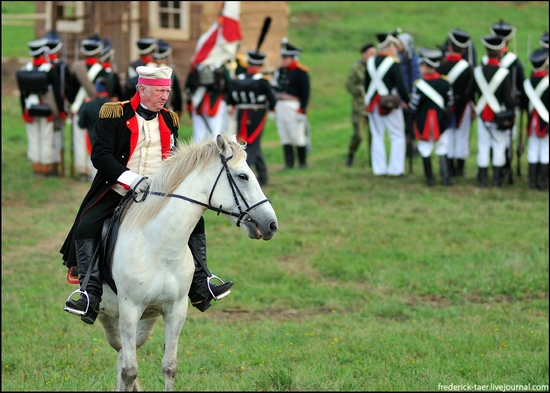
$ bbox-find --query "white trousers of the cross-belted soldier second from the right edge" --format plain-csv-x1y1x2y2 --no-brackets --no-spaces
477,116,511,168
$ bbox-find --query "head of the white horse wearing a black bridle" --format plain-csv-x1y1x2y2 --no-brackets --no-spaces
212,135,278,240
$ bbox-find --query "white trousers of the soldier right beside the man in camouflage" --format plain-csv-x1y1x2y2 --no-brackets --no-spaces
368,105,406,176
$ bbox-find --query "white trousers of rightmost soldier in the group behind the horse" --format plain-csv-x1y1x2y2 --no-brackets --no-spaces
275,100,308,147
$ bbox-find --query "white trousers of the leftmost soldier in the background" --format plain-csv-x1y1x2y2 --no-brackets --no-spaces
25,116,54,165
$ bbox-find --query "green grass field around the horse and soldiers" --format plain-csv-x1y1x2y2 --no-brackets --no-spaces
2,2,549,391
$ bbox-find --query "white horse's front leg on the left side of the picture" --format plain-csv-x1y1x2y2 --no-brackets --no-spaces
117,300,141,391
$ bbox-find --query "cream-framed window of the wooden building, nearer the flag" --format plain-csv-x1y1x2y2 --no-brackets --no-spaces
149,1,191,41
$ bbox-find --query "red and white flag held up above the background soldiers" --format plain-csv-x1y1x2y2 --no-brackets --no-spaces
191,1,242,66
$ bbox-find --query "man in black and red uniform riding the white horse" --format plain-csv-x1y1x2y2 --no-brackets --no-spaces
60,67,233,324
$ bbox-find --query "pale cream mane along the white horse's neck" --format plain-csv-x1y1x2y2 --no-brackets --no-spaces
125,135,246,229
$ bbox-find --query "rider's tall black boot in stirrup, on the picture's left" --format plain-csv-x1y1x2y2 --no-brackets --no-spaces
65,239,103,325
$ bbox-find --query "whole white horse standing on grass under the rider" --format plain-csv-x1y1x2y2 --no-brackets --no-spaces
94,136,278,391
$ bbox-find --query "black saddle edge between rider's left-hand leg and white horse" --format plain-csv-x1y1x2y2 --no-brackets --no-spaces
98,192,133,295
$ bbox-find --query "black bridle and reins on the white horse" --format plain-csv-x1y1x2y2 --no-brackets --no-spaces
136,153,269,227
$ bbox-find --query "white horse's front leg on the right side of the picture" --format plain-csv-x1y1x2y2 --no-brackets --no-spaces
162,296,188,392
